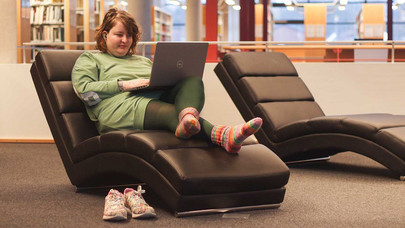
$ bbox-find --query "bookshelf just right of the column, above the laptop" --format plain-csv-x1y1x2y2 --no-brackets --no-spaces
152,7,173,41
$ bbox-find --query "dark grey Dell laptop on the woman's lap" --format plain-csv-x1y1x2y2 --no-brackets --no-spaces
132,42,208,91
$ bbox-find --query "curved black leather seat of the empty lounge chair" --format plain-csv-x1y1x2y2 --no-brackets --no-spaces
272,113,405,159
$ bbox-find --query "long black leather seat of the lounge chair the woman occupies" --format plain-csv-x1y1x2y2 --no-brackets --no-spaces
73,131,289,195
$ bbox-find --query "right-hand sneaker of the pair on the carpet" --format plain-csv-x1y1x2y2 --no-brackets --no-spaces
124,185,156,218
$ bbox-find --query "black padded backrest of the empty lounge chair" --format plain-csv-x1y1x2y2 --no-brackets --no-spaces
216,52,324,142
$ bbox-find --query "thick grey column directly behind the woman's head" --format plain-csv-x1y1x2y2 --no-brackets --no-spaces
128,0,153,41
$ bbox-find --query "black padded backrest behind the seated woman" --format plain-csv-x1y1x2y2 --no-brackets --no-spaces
31,50,99,174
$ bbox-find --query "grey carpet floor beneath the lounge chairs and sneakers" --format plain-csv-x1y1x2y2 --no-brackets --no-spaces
0,143,405,227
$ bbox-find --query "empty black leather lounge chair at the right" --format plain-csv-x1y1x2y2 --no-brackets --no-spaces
215,52,405,180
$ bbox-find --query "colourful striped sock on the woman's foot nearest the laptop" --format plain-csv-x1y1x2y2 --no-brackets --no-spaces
175,107,201,139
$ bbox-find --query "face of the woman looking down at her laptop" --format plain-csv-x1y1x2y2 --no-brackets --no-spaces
104,21,133,57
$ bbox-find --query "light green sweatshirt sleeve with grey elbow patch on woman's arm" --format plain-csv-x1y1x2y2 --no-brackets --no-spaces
72,52,120,106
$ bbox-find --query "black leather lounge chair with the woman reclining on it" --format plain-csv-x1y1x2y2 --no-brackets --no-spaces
31,50,289,216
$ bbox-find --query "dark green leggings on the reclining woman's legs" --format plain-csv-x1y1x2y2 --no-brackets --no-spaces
144,77,213,139
